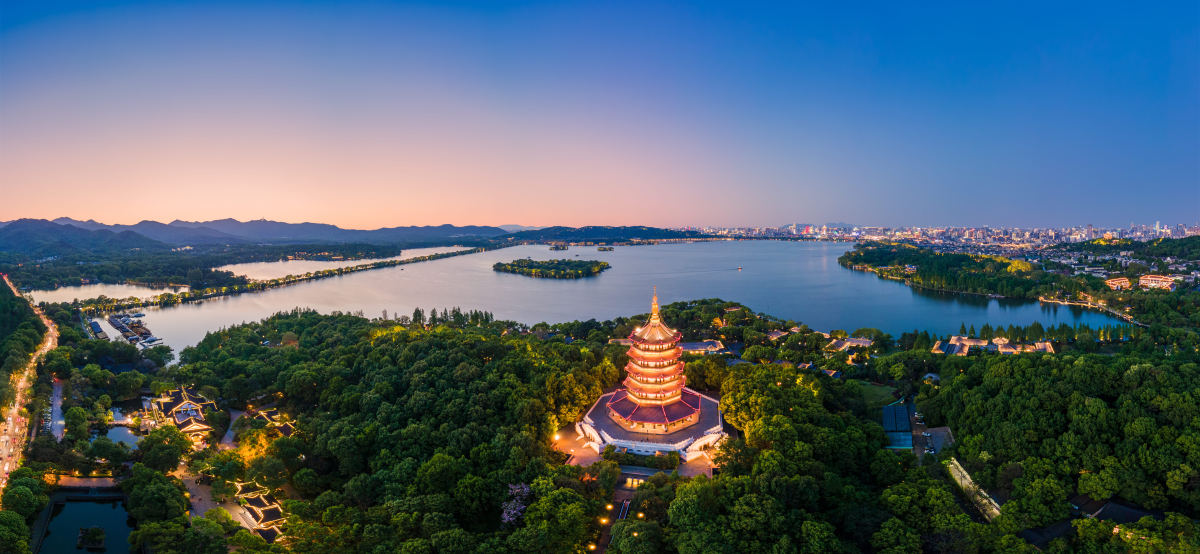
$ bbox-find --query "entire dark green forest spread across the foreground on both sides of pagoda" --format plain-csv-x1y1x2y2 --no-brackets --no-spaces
0,300,1200,554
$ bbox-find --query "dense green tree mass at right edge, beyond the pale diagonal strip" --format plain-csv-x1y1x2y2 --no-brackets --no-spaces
918,355,1200,526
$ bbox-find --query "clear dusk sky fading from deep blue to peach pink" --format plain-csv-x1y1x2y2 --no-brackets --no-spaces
0,0,1200,228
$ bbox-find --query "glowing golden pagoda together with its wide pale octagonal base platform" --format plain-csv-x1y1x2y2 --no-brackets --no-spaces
571,290,726,462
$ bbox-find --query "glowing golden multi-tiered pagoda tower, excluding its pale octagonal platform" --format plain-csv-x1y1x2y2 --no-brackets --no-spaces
607,290,701,434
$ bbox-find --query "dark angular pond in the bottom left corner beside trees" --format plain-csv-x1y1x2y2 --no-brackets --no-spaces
41,500,133,553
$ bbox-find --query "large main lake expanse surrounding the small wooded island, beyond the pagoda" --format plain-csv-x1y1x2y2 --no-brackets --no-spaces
136,241,1120,353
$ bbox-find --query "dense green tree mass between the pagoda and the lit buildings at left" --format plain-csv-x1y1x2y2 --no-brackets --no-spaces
172,311,619,552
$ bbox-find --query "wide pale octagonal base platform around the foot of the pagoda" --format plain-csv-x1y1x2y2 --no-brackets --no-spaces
575,389,726,462
